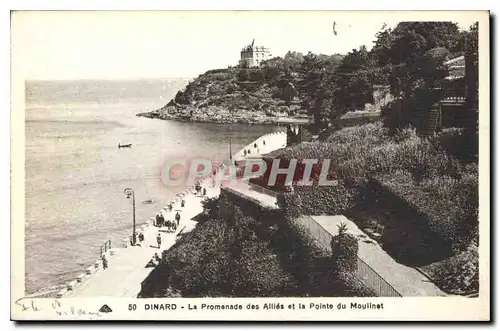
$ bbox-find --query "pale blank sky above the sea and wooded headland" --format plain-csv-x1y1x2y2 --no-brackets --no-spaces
11,11,474,80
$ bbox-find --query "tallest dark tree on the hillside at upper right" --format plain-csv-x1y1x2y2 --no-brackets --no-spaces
372,22,462,132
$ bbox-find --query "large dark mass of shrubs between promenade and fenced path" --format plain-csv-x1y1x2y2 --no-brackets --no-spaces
140,198,374,297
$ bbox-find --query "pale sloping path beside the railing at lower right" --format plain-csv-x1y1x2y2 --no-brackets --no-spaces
311,215,447,297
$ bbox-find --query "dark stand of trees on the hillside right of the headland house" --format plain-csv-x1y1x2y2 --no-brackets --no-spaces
301,22,464,132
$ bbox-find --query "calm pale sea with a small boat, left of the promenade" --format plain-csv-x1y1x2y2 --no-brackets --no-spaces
25,80,277,294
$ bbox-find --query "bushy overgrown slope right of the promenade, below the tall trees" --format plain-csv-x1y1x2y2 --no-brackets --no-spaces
269,123,478,293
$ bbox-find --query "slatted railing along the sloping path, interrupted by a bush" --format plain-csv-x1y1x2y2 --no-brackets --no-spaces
296,216,402,297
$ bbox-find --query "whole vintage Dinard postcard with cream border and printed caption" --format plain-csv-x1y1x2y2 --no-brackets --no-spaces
11,11,490,321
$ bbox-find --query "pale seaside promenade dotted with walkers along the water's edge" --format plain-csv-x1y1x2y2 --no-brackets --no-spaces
63,132,286,297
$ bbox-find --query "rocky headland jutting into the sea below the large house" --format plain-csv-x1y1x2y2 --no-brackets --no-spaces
137,68,309,124
